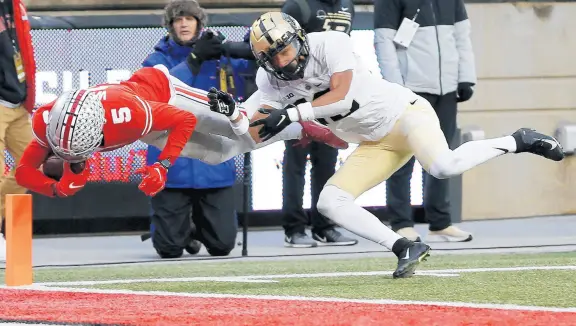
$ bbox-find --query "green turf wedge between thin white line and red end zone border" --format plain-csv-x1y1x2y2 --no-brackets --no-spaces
82,271,576,307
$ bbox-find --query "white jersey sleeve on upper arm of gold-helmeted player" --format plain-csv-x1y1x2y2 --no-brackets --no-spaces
324,31,356,75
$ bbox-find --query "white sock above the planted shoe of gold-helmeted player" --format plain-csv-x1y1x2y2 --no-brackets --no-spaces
317,185,402,250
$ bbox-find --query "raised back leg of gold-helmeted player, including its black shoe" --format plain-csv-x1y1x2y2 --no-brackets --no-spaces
398,98,564,179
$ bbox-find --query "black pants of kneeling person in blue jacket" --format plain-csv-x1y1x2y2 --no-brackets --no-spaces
151,187,238,257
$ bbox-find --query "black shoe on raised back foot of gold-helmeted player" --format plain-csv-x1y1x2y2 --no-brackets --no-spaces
512,128,565,161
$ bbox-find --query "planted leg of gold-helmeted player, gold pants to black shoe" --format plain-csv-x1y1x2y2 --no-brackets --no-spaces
317,122,430,278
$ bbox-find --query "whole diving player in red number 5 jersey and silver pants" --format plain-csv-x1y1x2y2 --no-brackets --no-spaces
16,65,347,197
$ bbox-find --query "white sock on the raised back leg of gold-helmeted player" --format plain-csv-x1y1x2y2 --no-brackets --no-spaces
429,136,516,179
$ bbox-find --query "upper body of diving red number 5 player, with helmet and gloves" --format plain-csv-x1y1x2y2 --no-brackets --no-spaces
16,68,196,197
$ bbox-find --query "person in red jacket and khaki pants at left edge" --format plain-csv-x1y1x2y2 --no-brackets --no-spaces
0,0,36,261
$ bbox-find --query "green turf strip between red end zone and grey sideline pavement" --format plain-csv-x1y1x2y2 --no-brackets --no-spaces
0,252,576,307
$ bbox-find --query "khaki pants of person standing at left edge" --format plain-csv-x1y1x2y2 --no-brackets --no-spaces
0,105,32,226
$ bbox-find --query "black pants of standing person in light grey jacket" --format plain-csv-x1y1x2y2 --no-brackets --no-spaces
386,92,457,231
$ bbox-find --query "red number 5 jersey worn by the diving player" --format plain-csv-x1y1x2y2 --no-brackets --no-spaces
16,68,196,196
